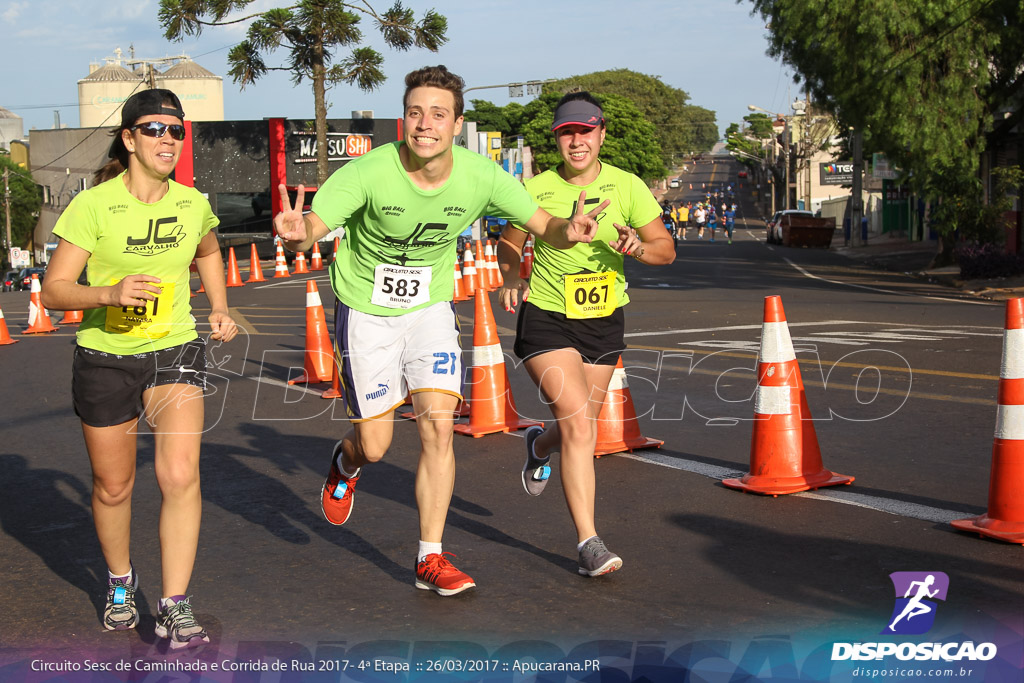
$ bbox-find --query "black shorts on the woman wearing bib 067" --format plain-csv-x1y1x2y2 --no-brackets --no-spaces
513,301,626,366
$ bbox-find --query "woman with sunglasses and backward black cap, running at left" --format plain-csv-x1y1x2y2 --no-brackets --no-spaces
42,90,238,649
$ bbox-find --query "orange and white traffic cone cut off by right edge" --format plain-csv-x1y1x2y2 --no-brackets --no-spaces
950,298,1024,544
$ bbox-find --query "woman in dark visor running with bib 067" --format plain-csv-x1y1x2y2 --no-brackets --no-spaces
498,92,676,577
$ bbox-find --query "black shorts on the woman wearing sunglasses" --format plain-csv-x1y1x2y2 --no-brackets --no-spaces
71,337,206,427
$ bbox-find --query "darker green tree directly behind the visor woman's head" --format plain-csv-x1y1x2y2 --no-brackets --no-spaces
521,92,666,180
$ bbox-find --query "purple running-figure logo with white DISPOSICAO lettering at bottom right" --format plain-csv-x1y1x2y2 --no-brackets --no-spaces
831,571,997,661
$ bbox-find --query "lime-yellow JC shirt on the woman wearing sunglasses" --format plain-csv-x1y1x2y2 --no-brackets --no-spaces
53,173,220,355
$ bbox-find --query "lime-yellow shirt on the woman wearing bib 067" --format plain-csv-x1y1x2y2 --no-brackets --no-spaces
519,162,662,313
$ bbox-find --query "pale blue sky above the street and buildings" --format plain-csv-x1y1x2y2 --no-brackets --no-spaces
0,0,801,139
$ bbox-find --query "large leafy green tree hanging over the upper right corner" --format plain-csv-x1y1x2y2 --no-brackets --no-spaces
751,0,1024,247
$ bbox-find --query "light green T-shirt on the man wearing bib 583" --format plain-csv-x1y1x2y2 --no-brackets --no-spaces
312,142,537,315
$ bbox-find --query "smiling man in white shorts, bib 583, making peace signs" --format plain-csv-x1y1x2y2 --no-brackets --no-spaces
274,67,622,595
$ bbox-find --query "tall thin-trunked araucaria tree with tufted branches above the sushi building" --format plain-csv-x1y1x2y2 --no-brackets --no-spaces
160,0,447,185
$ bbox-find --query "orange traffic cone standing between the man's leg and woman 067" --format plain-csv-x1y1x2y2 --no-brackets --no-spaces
455,288,544,437
